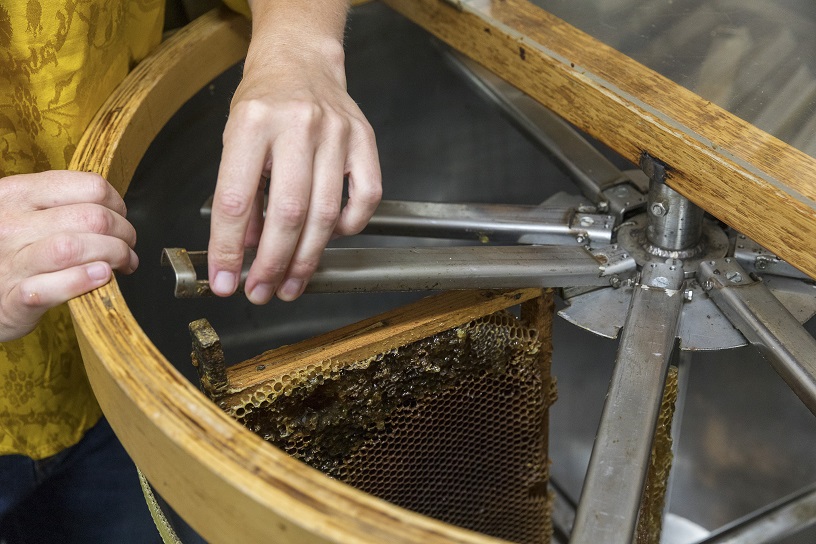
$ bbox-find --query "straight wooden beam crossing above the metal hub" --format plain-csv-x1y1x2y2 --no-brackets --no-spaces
383,0,816,278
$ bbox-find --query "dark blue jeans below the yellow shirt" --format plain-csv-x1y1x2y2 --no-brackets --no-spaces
0,418,199,544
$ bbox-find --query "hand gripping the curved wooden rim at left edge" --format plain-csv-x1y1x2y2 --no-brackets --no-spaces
0,170,139,342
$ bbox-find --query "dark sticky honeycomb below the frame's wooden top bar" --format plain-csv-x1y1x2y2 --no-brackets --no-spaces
221,311,554,543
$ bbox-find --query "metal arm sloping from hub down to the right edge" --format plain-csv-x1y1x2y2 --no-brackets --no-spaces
697,258,816,415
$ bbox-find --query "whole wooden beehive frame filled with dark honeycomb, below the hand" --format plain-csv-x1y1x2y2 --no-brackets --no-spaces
190,289,555,543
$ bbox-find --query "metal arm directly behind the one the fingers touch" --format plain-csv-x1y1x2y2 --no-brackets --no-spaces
363,200,615,245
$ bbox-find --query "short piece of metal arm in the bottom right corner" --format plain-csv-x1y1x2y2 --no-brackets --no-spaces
697,484,816,544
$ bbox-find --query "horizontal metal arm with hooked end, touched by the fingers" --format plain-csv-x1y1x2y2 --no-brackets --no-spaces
162,246,635,298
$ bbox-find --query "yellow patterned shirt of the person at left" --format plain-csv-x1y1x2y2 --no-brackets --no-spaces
0,0,164,459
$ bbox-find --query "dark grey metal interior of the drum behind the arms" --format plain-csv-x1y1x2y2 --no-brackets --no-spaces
119,4,816,543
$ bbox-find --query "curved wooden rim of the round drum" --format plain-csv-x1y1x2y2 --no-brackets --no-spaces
70,8,500,544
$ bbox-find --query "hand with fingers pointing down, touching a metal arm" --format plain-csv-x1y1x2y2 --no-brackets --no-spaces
204,17,382,304
